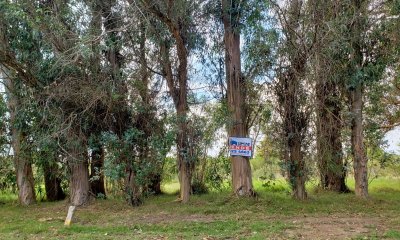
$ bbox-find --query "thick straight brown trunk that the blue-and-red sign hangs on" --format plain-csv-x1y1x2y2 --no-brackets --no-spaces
222,0,254,196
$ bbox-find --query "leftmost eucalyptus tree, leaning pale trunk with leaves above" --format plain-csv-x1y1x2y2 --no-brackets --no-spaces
0,2,37,205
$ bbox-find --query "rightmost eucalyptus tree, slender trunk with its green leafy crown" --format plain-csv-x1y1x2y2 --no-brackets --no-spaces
345,0,398,198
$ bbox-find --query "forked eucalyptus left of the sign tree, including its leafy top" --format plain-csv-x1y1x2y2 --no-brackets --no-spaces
140,0,205,203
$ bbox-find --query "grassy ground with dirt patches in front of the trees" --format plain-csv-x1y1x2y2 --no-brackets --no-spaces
0,179,400,239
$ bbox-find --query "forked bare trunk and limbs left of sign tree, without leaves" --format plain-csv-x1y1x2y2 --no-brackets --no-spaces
149,5,195,203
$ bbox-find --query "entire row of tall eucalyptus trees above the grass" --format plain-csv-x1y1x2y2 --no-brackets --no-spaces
0,0,400,206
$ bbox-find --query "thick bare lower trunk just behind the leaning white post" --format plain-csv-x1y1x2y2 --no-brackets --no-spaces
68,146,90,206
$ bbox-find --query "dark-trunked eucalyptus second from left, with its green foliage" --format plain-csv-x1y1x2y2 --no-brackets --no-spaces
1,1,75,201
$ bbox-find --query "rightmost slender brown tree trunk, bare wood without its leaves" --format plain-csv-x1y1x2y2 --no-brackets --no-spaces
349,0,368,198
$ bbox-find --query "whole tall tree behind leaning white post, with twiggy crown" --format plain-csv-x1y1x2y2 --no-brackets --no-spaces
26,0,95,206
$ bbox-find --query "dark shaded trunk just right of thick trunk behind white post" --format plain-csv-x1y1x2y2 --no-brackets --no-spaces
90,144,106,197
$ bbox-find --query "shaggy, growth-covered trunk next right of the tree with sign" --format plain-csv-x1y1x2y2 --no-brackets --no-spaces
275,0,310,200
